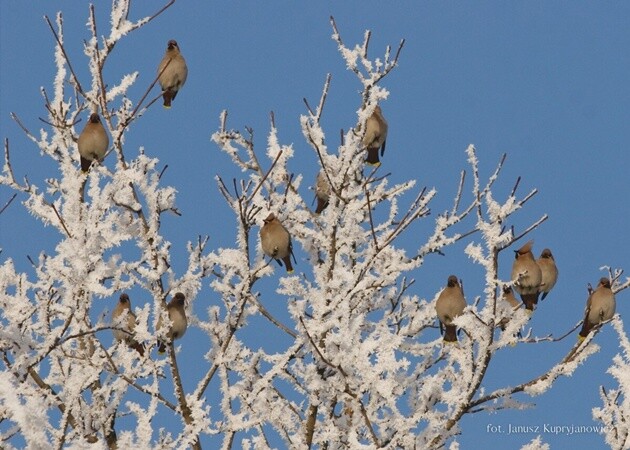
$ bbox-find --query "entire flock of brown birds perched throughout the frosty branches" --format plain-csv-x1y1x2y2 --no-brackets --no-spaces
77,40,616,354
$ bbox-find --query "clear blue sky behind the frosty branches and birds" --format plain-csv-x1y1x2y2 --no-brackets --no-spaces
0,0,630,448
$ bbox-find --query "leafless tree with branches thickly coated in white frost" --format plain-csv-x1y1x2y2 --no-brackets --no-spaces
0,1,630,448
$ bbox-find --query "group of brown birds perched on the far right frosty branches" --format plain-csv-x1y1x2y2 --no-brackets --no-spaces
435,241,616,343
